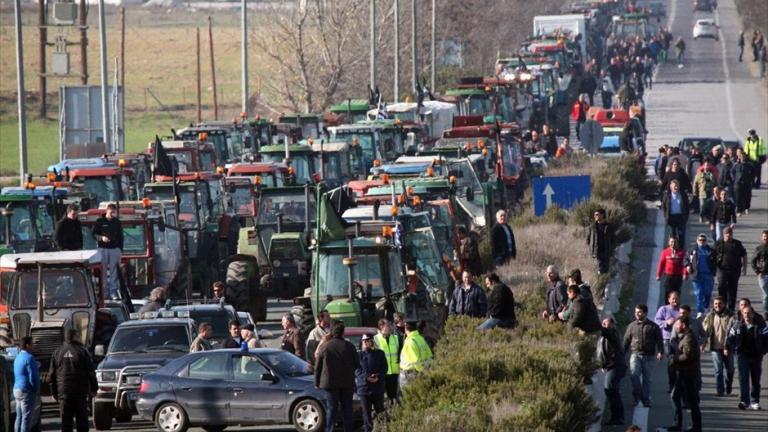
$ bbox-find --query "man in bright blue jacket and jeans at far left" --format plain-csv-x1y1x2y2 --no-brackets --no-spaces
13,336,40,432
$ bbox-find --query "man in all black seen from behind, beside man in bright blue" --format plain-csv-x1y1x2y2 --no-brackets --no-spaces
49,329,98,432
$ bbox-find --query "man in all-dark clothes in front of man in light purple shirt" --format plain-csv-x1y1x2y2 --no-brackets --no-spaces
667,316,701,432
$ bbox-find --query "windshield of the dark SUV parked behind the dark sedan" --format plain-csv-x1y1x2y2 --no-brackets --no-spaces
109,325,191,353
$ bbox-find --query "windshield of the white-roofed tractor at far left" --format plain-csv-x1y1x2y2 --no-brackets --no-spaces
11,269,90,309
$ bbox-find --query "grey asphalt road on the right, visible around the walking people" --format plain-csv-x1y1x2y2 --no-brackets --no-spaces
603,0,768,431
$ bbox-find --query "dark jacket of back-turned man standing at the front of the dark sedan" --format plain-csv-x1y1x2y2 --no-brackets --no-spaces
315,337,360,390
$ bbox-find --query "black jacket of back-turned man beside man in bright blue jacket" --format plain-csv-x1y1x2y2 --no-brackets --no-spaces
48,341,98,399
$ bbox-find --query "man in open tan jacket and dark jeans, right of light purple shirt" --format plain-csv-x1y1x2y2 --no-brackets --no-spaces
703,297,734,396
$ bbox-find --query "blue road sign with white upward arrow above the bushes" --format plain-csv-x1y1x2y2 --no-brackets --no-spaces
533,176,592,216
